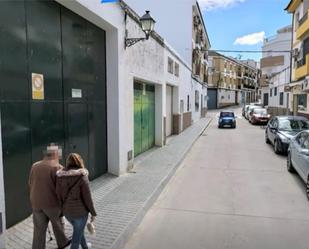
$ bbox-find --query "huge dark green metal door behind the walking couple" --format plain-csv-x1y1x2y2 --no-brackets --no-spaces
0,0,107,227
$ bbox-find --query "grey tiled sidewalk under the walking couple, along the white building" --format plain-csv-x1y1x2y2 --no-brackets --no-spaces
5,113,214,249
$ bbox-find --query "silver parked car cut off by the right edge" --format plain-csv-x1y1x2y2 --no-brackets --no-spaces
287,130,309,200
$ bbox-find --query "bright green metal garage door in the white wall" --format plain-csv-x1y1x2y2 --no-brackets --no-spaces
134,83,155,156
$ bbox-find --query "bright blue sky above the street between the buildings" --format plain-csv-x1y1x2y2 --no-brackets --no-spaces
199,0,292,60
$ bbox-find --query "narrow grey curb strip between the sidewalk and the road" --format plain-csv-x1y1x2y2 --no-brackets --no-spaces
110,117,214,249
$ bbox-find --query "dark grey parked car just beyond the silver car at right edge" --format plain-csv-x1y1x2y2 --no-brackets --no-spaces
265,116,309,154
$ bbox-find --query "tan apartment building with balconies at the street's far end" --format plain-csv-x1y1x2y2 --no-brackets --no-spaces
207,51,258,109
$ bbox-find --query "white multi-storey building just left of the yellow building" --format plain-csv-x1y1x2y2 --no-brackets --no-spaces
258,25,292,115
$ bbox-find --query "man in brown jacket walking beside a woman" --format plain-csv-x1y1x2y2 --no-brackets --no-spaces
29,145,71,249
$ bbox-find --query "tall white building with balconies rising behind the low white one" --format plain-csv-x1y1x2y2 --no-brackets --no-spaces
126,0,210,122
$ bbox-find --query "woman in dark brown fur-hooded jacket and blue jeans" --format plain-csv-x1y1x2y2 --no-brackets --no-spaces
56,153,96,249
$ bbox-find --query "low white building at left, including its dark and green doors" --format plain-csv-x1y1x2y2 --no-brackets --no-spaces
0,0,209,237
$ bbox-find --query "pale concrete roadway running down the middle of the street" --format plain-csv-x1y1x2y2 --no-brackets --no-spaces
125,109,309,249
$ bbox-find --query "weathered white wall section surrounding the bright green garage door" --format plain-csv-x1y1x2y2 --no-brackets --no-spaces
119,14,165,174
